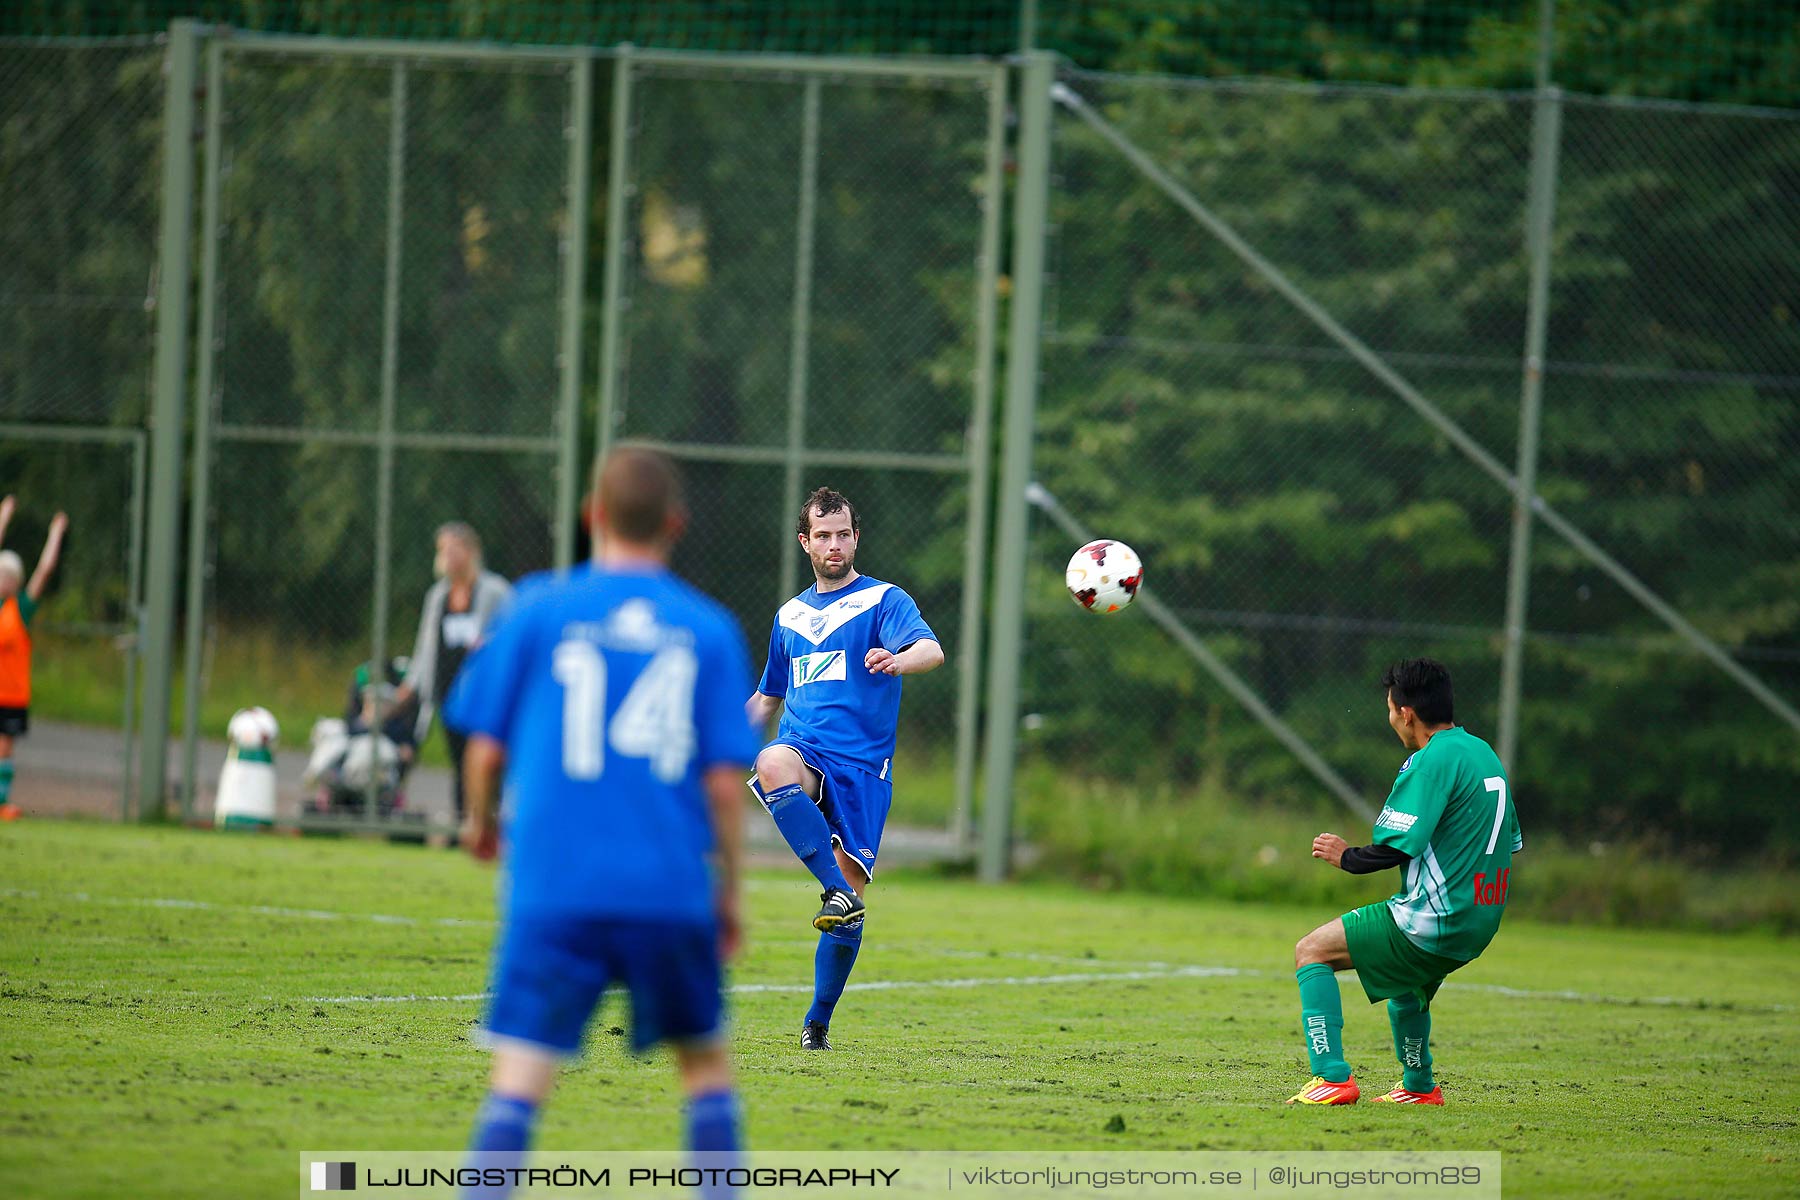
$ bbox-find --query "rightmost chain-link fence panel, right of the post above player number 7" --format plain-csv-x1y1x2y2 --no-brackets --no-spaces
1519,101,1800,849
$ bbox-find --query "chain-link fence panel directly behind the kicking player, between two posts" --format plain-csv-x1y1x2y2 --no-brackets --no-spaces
601,54,1004,845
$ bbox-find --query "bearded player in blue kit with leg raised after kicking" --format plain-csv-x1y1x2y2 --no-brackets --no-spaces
747,488,943,1051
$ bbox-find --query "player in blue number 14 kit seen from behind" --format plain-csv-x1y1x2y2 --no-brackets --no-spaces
446,448,758,1196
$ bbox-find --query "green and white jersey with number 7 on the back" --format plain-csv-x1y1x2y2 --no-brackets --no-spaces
1375,725,1525,963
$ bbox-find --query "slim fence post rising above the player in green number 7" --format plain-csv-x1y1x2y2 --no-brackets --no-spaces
1499,0,1562,770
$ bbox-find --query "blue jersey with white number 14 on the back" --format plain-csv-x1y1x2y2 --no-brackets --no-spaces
445,567,758,923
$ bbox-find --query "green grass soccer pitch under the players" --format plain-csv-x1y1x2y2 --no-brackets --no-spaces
0,822,1800,1200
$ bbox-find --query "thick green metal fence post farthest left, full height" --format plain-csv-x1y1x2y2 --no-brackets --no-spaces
137,20,200,819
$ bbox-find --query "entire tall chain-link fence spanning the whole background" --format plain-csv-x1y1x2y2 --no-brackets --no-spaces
0,21,1800,863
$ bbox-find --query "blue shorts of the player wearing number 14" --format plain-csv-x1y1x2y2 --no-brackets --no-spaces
482,916,724,1058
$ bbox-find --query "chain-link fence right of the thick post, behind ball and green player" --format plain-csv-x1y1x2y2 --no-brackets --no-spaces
1024,63,1800,844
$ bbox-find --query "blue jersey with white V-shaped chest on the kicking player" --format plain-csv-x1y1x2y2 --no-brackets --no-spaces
758,576,938,779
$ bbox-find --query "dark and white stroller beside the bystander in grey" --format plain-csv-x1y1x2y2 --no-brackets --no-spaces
302,657,425,820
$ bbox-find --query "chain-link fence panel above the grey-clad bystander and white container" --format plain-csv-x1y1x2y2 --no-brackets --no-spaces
174,36,592,822
